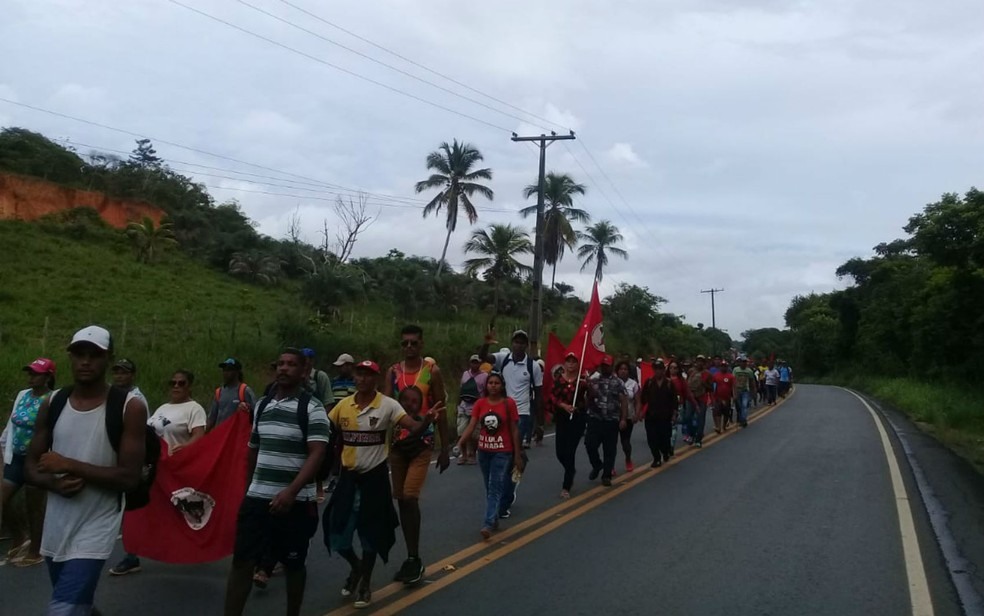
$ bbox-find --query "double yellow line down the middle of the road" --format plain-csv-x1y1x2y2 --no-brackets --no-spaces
325,391,793,616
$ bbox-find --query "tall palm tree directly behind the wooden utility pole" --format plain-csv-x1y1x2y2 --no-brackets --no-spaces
519,171,591,286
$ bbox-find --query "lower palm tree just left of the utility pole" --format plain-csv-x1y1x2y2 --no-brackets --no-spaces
465,225,533,322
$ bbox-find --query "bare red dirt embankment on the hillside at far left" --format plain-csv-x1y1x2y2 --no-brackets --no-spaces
0,173,164,229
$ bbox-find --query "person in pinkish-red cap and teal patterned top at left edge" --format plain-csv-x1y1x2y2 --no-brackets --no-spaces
0,357,55,567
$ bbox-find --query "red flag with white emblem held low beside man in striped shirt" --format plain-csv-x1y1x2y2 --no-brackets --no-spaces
123,412,252,563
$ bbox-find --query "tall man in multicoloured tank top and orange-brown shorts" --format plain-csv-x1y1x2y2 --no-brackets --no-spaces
383,325,452,584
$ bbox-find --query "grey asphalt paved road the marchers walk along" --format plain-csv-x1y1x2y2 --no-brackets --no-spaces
0,386,962,616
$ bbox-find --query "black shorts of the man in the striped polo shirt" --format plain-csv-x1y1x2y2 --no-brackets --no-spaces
233,496,318,571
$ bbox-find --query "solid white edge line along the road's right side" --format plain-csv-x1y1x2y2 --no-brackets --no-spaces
840,387,935,616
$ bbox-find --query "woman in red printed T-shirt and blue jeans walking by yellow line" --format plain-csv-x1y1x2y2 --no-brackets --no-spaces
458,372,525,539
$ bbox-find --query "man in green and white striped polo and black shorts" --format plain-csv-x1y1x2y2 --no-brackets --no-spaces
225,348,329,616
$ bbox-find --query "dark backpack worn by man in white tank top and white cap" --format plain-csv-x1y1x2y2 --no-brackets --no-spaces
48,386,161,511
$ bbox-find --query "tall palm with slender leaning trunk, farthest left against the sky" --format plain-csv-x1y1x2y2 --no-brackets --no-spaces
416,139,495,278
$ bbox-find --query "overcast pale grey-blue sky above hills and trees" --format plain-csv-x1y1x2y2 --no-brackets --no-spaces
0,0,984,337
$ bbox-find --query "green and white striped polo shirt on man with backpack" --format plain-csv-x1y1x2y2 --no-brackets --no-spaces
246,397,329,501
